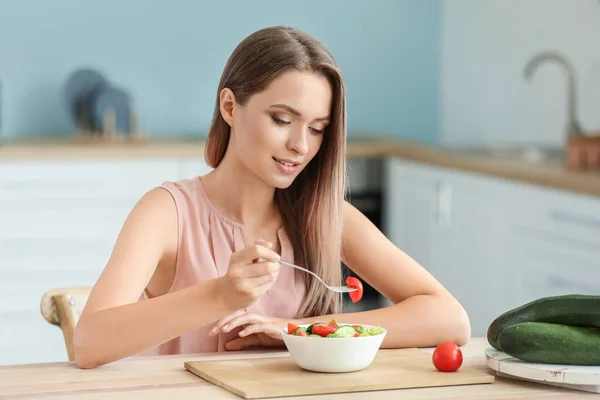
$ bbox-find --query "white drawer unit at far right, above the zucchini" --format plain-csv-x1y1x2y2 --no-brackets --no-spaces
507,178,600,304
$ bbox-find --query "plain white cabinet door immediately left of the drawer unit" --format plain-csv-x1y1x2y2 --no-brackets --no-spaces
433,166,512,336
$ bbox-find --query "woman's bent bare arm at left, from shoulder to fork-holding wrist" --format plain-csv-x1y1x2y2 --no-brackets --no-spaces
73,188,227,368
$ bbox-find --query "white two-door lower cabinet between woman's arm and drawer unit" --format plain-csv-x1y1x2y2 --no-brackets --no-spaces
385,158,508,336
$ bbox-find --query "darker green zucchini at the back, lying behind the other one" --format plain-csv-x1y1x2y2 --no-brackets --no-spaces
487,294,600,350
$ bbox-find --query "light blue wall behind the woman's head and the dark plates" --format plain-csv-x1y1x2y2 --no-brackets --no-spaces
0,0,441,141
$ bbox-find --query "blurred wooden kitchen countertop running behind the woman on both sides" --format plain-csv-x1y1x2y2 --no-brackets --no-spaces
0,135,600,197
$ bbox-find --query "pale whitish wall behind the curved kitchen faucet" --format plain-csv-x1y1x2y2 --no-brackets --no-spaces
439,0,600,148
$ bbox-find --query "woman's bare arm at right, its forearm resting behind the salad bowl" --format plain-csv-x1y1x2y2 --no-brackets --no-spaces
302,202,471,348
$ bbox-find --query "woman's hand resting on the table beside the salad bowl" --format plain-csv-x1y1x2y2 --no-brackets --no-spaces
210,311,297,350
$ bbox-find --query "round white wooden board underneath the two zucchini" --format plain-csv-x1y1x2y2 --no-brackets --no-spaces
485,347,600,393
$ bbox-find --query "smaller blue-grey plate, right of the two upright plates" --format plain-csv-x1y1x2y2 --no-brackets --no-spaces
92,86,132,134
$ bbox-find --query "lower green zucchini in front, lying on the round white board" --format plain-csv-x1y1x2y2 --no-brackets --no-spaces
498,322,600,366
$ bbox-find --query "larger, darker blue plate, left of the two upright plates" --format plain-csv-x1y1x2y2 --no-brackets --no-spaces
64,68,109,130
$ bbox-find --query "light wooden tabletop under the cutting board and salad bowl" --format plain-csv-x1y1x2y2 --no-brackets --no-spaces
0,338,597,400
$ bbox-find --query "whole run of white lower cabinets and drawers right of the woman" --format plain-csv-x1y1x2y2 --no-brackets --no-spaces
385,158,600,336
